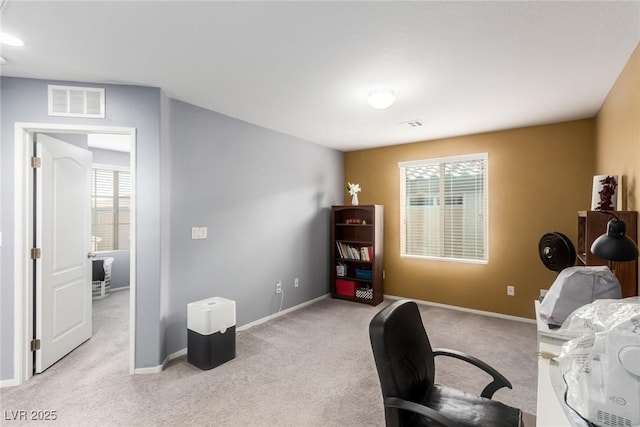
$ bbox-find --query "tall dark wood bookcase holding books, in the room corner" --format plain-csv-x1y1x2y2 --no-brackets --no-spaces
331,205,384,305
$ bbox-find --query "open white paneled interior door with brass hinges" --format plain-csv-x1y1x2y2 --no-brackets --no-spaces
35,134,92,373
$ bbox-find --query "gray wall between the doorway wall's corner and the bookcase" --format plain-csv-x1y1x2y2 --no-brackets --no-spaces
166,100,344,354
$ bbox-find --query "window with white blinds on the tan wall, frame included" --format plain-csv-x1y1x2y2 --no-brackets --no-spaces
398,153,488,263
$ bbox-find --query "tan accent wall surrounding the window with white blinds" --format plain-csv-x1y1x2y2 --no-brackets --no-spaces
344,119,596,318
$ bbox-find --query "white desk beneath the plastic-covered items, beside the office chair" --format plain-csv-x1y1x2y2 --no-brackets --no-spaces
535,301,571,427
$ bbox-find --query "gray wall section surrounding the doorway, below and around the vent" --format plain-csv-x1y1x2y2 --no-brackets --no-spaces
0,77,163,380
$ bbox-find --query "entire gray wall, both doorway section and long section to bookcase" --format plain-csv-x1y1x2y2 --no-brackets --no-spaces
0,77,344,380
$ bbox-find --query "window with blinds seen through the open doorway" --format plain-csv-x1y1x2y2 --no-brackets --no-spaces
91,168,131,251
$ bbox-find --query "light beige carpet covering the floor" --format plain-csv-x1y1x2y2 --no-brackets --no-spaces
0,291,537,426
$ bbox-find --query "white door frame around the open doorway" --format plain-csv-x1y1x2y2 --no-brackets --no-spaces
13,123,136,384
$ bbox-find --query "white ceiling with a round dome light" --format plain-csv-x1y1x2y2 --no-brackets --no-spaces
0,0,640,151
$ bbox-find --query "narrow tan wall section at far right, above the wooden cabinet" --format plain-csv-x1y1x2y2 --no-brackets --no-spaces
596,44,640,298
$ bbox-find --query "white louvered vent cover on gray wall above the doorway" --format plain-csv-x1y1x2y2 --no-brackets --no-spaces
49,85,105,119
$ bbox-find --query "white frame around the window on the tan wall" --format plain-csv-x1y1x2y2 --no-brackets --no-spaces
398,153,489,265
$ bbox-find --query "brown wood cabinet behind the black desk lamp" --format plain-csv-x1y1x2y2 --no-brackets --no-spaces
576,211,638,298
